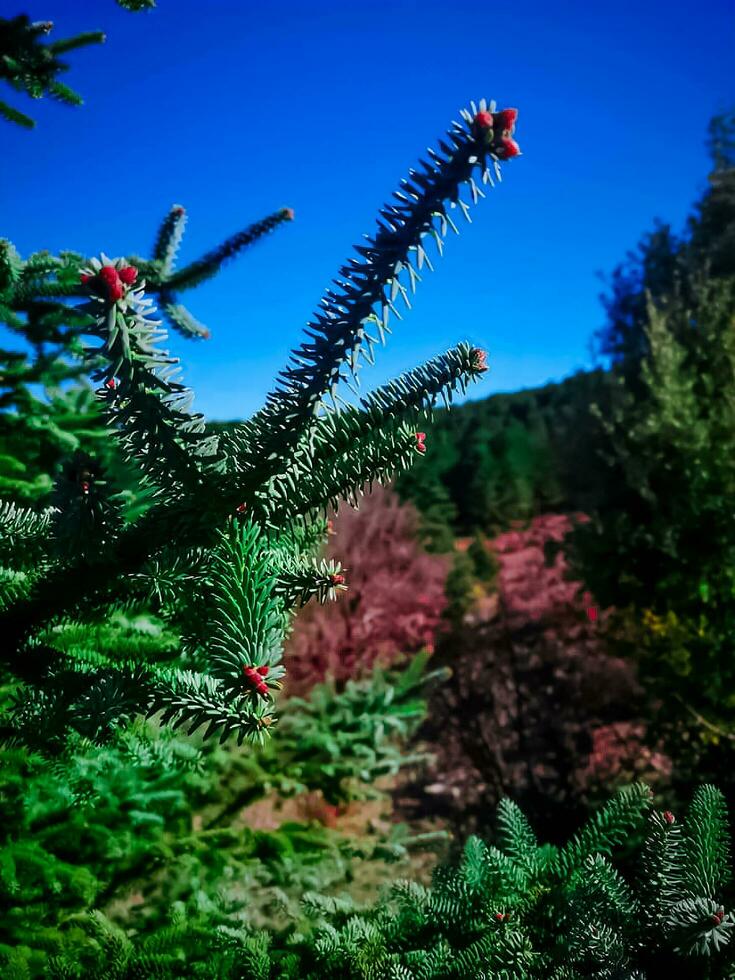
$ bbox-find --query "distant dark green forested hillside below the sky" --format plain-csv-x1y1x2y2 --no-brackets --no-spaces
398,369,609,547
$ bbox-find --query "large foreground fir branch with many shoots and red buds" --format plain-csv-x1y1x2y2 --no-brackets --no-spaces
0,101,519,742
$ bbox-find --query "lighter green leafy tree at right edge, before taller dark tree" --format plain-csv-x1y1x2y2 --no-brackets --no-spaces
569,279,735,748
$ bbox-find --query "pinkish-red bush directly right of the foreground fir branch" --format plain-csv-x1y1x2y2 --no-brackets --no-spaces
286,486,448,693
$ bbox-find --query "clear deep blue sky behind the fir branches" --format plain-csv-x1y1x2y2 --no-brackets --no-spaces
0,0,735,418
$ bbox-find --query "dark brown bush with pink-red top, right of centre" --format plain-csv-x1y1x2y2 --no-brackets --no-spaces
407,514,669,837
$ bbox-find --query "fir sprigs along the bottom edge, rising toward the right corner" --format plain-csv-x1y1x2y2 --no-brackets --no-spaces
5,785,733,980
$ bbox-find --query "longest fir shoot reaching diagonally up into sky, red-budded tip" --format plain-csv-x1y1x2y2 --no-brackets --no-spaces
250,100,520,478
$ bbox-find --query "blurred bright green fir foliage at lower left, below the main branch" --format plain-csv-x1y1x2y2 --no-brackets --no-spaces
0,660,442,976
